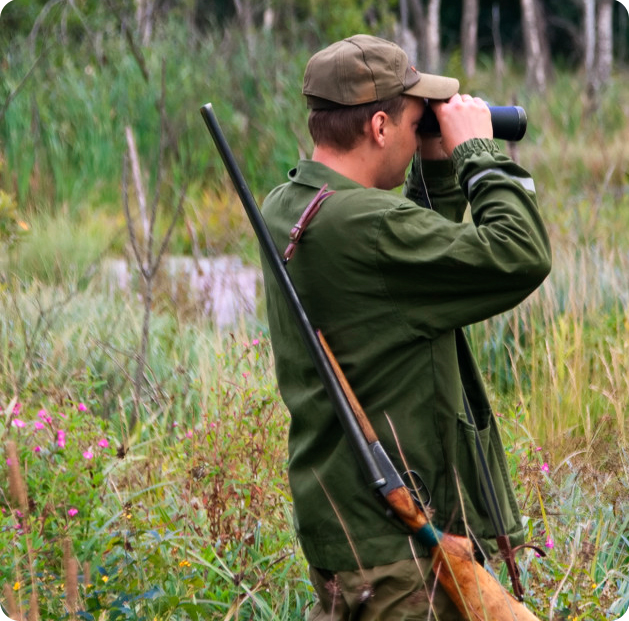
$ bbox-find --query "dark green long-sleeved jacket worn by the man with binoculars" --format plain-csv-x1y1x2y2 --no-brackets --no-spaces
262,139,550,571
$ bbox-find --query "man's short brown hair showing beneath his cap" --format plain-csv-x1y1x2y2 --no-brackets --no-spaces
308,95,408,151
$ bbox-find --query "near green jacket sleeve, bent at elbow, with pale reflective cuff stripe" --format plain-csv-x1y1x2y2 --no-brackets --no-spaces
378,139,551,337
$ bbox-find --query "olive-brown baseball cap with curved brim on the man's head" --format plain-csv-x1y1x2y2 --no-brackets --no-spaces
302,34,459,110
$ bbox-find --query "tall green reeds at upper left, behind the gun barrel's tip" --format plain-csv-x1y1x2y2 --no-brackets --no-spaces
0,20,308,213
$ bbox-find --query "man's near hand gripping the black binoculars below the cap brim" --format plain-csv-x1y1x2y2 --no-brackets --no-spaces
430,93,494,159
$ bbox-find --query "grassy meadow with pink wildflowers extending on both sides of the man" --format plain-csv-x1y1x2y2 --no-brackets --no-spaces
0,19,629,621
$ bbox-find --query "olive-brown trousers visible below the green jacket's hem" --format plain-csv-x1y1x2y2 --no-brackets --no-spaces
308,558,465,621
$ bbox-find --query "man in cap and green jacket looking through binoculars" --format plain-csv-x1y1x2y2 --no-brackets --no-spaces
262,35,550,621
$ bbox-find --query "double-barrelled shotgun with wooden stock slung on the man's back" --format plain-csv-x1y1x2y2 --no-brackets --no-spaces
201,103,539,621
